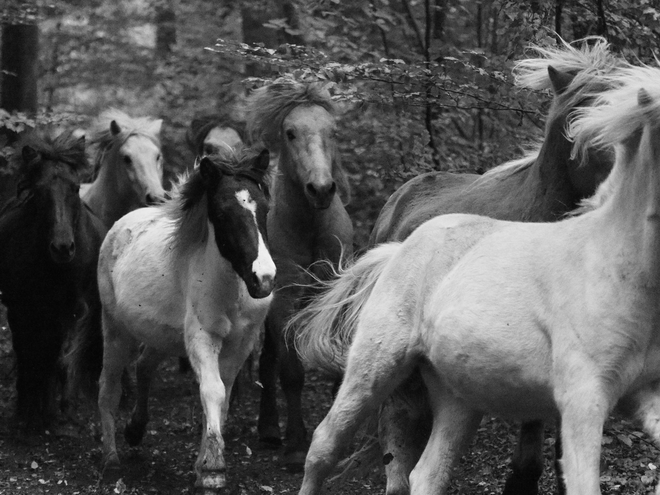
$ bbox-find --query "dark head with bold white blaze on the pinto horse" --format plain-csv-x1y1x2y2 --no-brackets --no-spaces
199,151,275,298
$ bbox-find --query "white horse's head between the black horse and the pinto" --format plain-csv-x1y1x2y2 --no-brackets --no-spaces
110,120,165,208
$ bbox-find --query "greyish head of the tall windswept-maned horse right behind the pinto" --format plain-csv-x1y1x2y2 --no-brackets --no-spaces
280,105,337,209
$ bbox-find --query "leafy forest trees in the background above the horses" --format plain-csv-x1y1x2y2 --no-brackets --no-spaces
0,0,660,245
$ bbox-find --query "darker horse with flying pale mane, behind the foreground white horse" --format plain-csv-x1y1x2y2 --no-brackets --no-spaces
360,38,621,495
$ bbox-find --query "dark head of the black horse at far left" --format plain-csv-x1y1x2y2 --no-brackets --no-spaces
17,132,86,264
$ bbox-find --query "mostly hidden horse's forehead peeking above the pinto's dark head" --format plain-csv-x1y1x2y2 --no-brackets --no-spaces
186,115,245,156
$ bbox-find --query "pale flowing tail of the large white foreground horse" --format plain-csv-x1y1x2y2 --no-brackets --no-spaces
285,242,401,376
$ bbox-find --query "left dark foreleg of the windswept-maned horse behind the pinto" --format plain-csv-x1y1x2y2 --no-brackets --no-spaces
257,318,282,447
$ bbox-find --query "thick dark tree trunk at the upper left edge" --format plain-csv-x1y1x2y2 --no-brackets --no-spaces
0,24,39,114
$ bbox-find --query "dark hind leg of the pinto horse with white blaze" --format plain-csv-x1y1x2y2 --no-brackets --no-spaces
124,346,165,447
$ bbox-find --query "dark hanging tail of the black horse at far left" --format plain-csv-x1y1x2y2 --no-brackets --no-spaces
64,294,103,397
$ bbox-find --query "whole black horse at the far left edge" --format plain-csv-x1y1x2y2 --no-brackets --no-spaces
0,132,106,427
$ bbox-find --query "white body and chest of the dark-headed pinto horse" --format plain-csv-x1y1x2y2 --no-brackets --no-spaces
101,208,272,356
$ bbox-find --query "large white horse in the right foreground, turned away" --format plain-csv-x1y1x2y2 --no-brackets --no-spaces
297,67,660,495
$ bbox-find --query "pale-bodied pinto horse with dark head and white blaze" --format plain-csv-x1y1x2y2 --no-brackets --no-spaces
98,151,275,490
